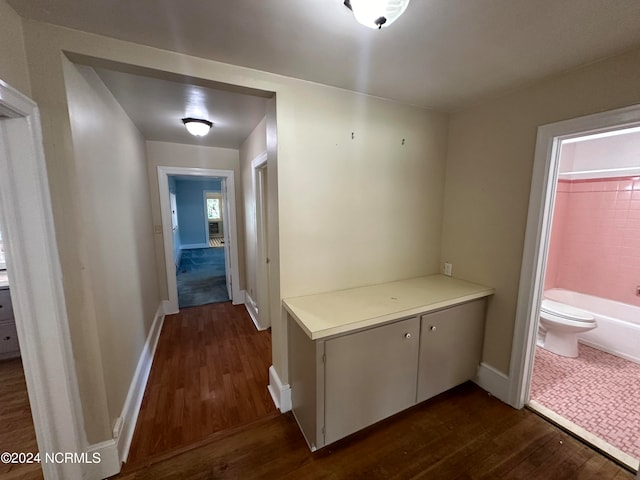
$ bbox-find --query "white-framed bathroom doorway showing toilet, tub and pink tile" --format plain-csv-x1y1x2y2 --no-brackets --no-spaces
512,109,640,470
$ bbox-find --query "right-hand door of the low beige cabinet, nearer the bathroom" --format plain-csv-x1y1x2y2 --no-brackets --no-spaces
418,299,485,402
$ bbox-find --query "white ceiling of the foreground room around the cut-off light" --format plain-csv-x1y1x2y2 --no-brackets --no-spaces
9,0,640,111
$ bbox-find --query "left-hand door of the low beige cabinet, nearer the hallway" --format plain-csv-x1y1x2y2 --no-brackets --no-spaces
325,317,420,444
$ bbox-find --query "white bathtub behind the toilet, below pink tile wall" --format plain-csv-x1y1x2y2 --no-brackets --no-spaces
544,288,640,363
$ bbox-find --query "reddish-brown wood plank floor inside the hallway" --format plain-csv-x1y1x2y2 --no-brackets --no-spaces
124,302,276,471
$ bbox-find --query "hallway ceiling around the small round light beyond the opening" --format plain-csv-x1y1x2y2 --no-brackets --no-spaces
95,68,266,149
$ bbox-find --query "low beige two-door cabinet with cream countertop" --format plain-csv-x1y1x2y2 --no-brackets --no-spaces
284,278,493,451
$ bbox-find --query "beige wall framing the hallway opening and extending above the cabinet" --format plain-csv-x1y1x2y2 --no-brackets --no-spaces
24,18,447,442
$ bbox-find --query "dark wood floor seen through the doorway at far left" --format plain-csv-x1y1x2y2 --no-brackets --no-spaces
0,358,42,480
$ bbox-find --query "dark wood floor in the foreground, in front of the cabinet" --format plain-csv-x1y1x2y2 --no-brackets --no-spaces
117,383,634,480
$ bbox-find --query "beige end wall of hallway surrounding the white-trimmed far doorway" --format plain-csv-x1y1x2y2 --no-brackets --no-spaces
146,141,245,299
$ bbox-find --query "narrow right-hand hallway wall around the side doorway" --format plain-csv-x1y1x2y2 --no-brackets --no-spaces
240,117,267,302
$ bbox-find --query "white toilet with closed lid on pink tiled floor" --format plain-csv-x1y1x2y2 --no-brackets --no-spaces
539,298,598,358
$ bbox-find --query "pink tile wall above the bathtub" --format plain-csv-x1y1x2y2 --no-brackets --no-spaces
545,177,640,306
